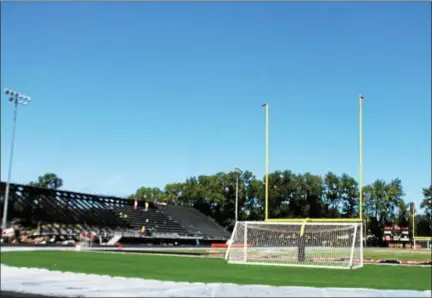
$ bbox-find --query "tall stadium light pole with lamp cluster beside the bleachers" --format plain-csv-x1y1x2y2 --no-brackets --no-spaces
2,89,31,230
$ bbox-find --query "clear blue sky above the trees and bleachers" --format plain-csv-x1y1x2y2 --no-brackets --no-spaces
1,2,431,212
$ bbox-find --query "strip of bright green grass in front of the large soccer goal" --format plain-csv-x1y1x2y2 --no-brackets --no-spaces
1,251,432,290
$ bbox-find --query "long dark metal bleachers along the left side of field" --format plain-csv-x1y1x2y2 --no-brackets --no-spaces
0,182,230,242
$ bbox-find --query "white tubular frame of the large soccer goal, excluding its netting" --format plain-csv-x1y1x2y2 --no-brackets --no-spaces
224,219,364,270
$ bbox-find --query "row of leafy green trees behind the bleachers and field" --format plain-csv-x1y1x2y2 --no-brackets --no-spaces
30,170,432,244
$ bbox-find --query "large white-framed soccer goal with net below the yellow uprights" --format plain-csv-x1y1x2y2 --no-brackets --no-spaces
225,222,363,269
